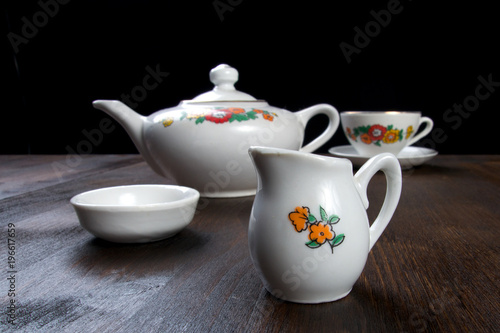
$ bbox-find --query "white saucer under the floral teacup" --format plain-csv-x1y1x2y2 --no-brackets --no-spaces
328,145,438,169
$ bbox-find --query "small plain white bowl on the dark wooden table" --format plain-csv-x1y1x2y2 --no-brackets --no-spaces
70,185,200,243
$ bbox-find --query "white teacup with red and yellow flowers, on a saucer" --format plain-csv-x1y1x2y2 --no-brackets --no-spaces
340,111,434,157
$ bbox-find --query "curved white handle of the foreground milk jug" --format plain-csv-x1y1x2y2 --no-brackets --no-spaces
354,153,402,250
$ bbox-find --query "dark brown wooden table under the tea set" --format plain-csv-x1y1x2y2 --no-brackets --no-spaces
0,155,500,332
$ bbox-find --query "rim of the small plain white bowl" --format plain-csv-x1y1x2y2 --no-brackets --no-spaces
70,184,200,210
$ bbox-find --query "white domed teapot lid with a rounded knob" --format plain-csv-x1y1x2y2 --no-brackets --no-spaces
191,64,257,102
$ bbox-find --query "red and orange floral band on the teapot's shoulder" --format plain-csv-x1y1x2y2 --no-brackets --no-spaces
162,108,278,127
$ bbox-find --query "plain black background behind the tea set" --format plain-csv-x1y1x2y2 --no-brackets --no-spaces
0,0,500,154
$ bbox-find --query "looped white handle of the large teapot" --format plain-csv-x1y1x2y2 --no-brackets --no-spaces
295,104,340,153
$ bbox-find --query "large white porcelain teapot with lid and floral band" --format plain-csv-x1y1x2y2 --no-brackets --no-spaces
93,65,340,197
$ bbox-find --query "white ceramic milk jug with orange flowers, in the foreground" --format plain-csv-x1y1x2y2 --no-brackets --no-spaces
248,147,401,303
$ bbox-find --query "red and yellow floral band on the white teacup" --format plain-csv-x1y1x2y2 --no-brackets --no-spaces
346,124,414,146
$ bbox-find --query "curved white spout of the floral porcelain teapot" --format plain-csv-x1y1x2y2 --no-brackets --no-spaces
92,100,164,176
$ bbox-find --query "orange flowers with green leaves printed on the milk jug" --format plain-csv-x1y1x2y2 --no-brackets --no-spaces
288,206,345,253
